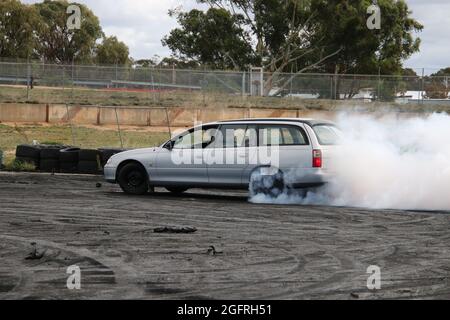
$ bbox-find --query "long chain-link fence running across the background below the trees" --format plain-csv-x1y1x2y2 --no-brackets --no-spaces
0,61,449,106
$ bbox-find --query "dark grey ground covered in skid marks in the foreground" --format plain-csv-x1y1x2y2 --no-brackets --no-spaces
0,173,450,299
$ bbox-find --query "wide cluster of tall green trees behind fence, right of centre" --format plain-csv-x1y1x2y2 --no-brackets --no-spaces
163,0,423,92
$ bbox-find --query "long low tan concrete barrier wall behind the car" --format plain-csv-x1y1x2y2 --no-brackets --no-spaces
0,103,428,127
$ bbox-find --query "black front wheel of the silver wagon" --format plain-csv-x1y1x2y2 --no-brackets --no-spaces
117,162,149,195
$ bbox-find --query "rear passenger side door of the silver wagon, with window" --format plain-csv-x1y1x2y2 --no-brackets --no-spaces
207,124,257,187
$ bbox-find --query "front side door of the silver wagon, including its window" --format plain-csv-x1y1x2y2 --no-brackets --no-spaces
151,126,218,186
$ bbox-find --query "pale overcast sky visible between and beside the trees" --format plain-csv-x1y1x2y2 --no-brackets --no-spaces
22,0,450,69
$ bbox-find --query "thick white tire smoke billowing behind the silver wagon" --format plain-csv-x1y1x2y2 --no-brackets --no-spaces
251,114,450,210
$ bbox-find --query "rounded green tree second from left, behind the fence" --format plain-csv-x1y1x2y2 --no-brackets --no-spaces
33,0,103,63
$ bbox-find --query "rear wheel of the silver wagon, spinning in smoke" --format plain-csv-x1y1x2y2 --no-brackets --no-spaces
249,168,286,198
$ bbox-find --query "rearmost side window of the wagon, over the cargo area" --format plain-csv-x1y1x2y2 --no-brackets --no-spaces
259,125,308,146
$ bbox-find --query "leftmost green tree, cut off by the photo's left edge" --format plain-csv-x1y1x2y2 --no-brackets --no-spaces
0,0,39,59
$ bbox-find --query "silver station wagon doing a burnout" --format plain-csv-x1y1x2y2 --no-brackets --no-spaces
105,118,341,196
